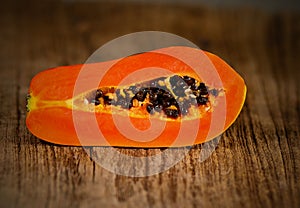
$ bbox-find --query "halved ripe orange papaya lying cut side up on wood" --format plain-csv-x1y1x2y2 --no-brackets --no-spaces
26,46,246,148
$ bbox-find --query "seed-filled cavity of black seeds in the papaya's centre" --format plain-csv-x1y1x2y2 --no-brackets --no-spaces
83,75,221,119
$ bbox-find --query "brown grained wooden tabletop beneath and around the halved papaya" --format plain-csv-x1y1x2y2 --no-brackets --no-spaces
0,1,300,208
